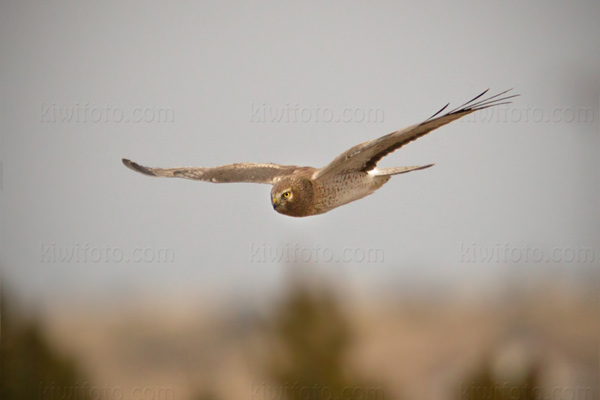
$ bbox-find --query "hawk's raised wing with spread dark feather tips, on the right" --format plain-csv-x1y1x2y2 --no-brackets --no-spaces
313,89,518,179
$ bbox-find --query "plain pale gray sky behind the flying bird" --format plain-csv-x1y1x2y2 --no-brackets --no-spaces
0,1,600,303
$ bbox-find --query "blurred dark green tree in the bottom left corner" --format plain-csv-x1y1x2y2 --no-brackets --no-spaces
0,295,89,400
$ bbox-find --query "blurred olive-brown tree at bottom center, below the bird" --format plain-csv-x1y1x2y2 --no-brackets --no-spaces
258,285,384,400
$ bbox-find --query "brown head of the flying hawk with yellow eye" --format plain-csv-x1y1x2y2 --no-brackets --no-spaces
271,176,313,217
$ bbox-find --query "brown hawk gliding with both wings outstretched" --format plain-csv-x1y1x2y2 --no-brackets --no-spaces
123,89,518,217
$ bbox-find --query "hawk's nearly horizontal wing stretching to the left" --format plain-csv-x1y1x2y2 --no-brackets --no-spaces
123,159,299,184
